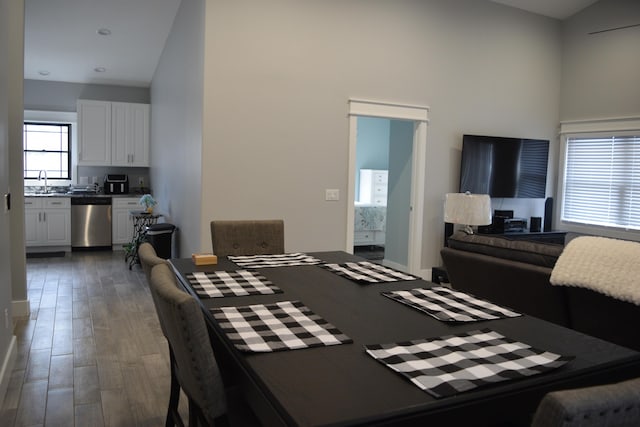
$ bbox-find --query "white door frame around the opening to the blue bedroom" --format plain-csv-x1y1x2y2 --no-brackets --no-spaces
345,99,429,275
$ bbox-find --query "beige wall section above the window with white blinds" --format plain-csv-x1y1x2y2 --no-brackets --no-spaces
560,0,640,120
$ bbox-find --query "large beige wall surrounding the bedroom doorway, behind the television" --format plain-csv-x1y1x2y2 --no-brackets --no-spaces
152,0,560,268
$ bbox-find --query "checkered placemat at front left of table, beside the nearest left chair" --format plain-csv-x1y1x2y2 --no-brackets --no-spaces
211,301,353,352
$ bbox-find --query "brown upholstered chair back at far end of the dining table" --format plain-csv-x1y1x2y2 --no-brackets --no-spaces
211,219,284,256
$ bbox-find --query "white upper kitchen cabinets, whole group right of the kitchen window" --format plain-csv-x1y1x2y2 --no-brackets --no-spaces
78,100,149,167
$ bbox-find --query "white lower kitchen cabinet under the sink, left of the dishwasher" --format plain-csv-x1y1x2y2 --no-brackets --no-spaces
24,197,71,247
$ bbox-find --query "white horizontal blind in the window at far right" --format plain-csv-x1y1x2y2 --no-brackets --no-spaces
562,136,640,230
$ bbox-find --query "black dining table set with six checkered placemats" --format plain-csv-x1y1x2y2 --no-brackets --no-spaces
169,251,640,426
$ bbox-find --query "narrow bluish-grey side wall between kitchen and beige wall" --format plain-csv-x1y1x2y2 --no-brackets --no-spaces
150,0,205,257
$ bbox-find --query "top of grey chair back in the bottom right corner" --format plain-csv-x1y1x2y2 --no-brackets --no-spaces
531,378,640,427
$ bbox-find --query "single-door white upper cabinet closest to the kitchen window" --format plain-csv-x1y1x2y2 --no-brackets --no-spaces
78,100,111,166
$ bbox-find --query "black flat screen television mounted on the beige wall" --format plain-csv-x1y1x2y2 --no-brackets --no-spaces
460,135,549,198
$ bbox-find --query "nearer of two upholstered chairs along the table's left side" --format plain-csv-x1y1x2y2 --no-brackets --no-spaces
150,263,229,427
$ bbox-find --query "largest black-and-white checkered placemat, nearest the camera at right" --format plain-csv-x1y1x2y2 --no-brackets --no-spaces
365,329,574,398
